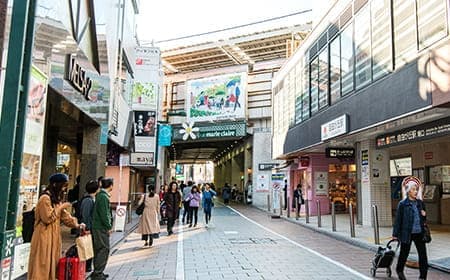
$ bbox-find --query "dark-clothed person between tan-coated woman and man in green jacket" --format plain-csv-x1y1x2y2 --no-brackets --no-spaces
80,180,98,272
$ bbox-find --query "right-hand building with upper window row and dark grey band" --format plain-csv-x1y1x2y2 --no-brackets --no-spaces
273,0,450,226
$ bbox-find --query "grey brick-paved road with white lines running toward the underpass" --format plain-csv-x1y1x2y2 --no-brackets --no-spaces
106,203,449,280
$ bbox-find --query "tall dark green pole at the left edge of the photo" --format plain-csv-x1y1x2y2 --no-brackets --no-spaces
0,0,36,279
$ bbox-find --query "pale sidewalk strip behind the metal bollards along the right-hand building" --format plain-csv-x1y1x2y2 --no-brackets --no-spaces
270,211,450,272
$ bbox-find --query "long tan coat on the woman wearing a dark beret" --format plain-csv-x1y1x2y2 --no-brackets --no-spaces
27,195,77,280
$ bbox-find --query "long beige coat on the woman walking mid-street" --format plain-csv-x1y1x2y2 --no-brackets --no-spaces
137,194,161,234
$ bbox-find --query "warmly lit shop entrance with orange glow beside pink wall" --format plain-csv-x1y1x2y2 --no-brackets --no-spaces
328,164,357,213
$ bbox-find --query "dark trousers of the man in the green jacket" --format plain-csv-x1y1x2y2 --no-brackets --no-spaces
91,229,109,279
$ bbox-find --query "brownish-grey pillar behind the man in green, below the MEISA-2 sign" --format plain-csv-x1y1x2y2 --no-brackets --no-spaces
80,126,106,201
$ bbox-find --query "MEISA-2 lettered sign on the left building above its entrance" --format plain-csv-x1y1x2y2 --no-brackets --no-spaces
64,54,92,100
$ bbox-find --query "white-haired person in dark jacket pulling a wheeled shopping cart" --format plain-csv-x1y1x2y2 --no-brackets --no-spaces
392,181,428,280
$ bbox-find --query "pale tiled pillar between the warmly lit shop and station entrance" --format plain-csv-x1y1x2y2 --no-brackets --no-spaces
357,140,392,226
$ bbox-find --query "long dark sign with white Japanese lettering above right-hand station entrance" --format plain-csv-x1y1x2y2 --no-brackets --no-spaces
376,118,450,148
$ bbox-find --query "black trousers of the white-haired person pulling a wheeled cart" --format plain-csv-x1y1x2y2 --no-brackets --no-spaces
396,233,428,279
